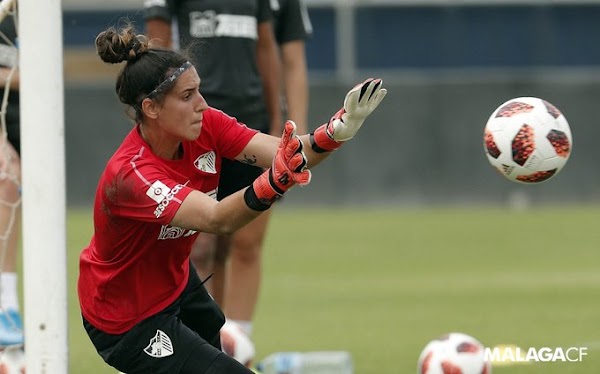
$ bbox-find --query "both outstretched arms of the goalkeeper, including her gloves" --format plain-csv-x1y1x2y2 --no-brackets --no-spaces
183,78,387,218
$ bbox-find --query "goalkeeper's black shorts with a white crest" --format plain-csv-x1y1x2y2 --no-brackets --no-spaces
83,265,251,374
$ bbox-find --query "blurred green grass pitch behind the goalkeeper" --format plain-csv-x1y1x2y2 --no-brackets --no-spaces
67,206,600,374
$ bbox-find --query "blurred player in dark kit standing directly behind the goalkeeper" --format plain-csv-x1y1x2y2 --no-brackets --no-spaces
144,0,282,356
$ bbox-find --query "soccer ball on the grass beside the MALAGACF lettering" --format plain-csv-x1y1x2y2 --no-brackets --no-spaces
417,332,492,374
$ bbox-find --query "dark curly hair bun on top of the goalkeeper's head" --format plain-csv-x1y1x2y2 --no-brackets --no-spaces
96,25,149,64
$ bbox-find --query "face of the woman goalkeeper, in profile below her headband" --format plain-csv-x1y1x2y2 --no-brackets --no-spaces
158,66,208,141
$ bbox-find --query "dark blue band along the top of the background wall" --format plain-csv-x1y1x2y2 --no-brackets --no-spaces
63,4,600,70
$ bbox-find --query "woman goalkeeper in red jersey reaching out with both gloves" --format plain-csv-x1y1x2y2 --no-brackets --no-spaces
78,26,387,374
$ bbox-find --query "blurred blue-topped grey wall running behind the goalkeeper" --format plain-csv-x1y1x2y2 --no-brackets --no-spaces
64,3,600,204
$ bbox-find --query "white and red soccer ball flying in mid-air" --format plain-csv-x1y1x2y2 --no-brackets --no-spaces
483,97,573,183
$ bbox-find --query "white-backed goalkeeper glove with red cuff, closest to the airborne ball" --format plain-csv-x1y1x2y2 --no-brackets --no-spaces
310,78,387,153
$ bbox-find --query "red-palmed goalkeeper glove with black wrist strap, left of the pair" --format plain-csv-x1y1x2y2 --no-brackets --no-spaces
244,120,311,211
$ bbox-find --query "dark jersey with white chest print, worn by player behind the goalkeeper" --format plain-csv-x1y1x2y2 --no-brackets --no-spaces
145,0,272,132
